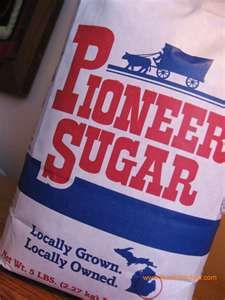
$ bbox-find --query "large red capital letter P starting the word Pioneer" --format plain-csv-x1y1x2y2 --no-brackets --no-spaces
53,25,114,114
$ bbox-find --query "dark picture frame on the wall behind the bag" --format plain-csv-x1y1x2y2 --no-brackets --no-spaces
0,0,63,97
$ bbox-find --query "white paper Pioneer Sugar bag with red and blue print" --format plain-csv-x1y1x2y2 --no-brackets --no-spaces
0,0,225,300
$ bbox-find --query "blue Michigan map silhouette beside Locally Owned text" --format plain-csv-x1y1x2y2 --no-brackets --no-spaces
114,247,162,300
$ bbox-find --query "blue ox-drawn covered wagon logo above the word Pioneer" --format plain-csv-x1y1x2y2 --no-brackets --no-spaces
107,43,225,108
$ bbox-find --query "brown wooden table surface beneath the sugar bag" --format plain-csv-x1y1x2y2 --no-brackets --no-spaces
0,176,225,300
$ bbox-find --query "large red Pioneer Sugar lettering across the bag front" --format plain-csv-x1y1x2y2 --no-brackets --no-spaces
42,25,225,205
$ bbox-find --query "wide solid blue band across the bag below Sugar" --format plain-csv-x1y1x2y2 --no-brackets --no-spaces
19,155,219,256
